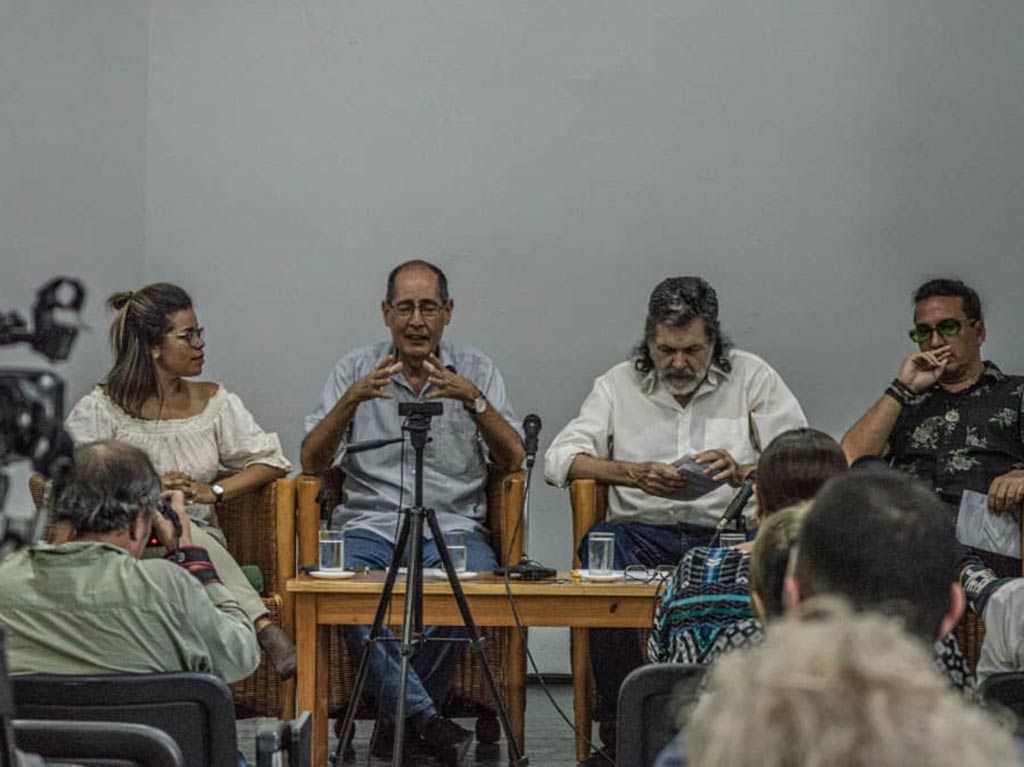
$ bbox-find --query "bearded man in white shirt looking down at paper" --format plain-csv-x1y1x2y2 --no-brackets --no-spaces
545,276,807,766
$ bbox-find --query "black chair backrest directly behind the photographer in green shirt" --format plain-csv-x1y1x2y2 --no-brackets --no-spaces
11,672,239,767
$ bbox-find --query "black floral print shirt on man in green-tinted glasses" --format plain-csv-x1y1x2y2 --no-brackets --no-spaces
889,360,1024,512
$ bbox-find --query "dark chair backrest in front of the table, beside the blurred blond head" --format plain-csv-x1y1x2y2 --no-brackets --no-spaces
615,664,708,767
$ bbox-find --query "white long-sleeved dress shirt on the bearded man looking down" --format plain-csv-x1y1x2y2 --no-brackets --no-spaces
544,349,807,526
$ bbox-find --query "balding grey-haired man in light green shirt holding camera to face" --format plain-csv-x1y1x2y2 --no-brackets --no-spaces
0,440,259,682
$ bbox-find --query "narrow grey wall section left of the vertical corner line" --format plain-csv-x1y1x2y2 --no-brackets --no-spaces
0,0,146,511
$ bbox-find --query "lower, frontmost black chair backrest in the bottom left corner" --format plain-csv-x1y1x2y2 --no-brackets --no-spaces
14,719,186,767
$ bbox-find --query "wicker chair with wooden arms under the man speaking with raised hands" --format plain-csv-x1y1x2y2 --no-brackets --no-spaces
296,468,526,747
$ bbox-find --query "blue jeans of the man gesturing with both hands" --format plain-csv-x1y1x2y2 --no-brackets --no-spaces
344,529,498,720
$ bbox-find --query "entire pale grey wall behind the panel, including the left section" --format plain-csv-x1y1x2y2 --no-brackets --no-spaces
0,0,1024,670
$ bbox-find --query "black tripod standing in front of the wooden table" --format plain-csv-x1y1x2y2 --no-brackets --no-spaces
332,402,529,767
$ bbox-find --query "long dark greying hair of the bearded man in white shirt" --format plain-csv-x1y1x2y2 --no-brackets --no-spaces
630,276,732,373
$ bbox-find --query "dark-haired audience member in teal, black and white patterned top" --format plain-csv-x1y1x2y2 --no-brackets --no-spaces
647,428,847,665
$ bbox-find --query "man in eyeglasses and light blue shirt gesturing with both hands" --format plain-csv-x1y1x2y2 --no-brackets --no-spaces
301,260,525,765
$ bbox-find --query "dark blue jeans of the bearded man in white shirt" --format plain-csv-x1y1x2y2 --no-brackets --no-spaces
578,522,715,722
